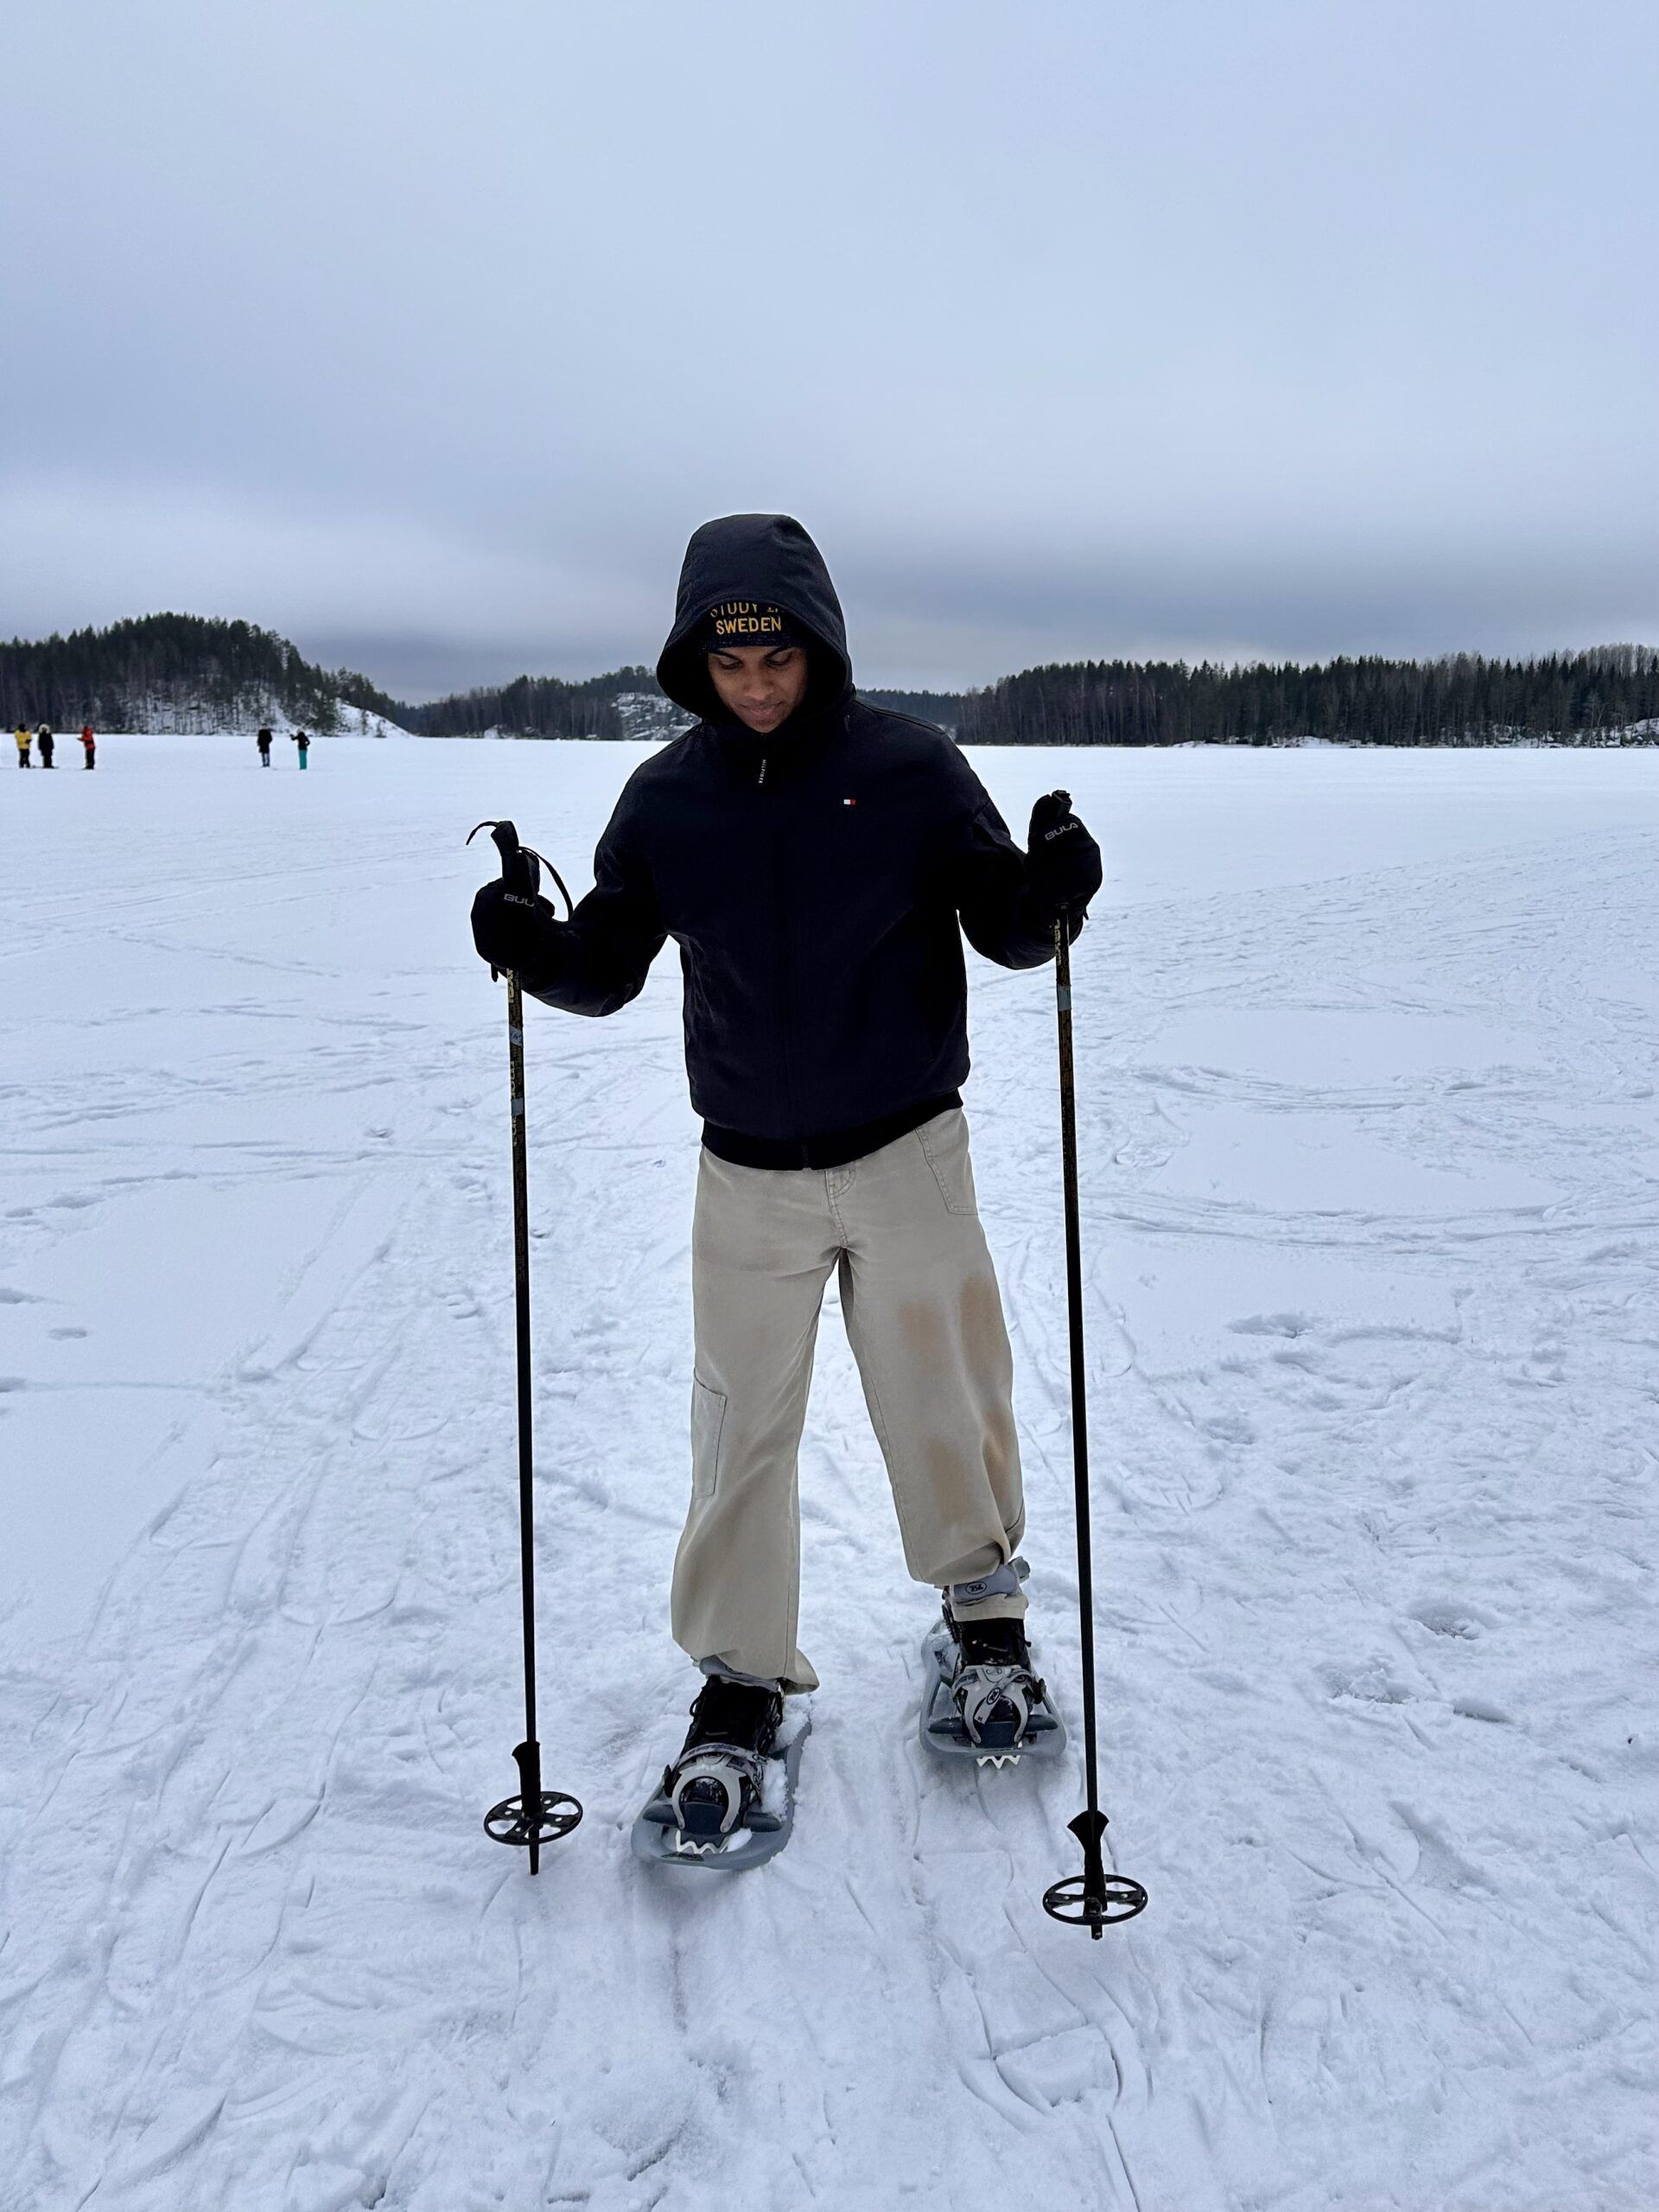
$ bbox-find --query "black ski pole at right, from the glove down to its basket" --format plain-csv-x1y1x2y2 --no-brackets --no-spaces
1042,880,1146,1942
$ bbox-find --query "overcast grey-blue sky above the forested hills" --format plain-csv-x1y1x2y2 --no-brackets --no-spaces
0,0,1659,696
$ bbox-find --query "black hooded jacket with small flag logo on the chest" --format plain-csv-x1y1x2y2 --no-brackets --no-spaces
520,515,1082,1168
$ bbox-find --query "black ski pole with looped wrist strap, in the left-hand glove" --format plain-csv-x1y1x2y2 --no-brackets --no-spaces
467,823,582,1873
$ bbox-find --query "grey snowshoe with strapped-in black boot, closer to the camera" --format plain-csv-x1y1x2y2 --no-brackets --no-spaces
632,1675,812,1873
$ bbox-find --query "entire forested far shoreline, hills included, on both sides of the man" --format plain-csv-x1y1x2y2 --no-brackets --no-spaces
0,615,1659,746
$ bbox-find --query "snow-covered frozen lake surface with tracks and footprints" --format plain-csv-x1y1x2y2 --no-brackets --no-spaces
0,736,1659,2212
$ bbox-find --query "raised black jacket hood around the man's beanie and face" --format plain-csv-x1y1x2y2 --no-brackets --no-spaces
657,515,852,721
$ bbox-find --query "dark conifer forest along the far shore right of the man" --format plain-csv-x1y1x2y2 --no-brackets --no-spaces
957,646,1659,746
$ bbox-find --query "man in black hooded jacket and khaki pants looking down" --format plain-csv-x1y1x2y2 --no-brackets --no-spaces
474,515,1102,1825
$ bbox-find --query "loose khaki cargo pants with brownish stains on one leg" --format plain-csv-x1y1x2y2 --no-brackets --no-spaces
672,1109,1024,1690
